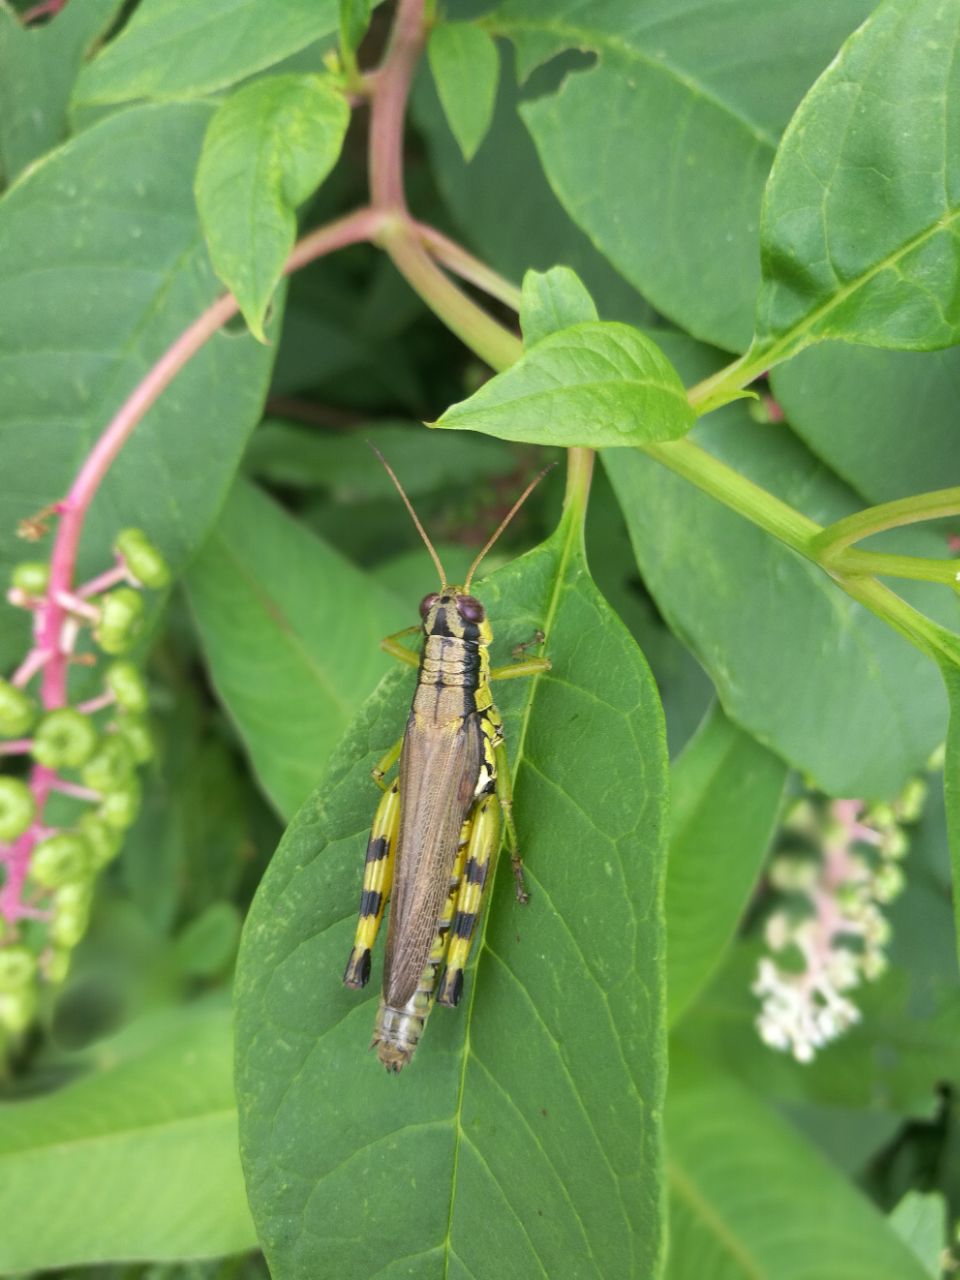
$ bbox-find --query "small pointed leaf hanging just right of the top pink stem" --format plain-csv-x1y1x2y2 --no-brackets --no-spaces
426,22,500,160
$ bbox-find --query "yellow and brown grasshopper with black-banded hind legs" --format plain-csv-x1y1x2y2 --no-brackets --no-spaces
343,451,550,1073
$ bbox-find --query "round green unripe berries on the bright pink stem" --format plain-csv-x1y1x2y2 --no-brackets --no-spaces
0,529,170,1034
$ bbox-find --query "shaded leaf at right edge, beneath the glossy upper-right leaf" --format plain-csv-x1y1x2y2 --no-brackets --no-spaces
772,342,960,503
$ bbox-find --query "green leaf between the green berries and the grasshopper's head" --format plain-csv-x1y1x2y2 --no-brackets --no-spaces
187,483,415,817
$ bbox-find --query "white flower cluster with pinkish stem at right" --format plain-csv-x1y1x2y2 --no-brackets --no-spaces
751,782,925,1062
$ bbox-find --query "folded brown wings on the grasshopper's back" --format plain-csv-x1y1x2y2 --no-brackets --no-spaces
383,713,481,1009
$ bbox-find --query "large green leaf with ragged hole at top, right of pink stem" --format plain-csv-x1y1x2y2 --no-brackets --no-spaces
490,0,872,348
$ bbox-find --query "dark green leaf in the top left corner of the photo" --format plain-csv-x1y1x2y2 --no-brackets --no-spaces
0,0,123,184
